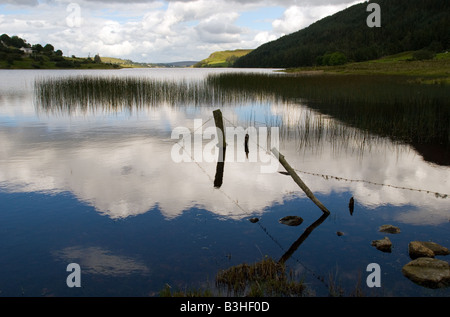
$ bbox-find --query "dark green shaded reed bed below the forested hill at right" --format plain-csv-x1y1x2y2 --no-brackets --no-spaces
208,73,450,149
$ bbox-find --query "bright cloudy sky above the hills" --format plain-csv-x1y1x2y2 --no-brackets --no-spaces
0,0,363,63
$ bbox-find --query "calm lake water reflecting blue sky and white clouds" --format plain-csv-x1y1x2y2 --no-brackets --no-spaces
0,69,450,297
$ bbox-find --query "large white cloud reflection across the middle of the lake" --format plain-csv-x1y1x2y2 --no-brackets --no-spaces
0,70,450,224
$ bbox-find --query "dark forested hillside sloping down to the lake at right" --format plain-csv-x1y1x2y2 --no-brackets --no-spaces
234,0,450,68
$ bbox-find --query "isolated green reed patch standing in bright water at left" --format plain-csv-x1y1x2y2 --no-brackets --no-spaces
35,76,280,113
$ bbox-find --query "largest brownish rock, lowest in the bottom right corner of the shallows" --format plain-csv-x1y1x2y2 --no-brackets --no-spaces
402,258,450,288
